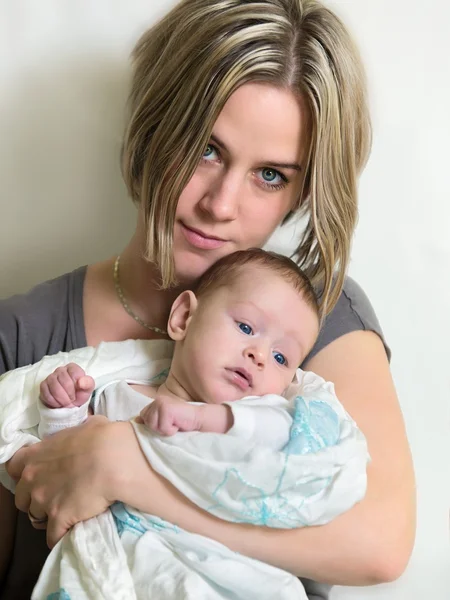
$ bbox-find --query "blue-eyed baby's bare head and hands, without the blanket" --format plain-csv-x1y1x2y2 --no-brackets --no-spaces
40,249,319,435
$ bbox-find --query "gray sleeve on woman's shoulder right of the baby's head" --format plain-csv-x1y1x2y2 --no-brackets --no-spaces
304,277,391,363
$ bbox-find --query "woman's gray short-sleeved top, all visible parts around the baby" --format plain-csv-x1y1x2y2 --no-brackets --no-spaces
0,267,390,600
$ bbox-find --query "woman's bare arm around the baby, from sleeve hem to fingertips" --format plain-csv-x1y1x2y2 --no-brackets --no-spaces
10,331,415,585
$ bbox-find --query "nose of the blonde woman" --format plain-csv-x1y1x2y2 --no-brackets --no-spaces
199,174,242,221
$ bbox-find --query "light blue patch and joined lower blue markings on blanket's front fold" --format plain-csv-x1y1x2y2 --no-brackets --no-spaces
208,396,340,529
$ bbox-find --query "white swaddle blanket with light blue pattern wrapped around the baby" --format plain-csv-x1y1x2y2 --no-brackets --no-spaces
0,341,368,600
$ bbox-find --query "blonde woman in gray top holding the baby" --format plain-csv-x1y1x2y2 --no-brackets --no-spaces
0,0,414,599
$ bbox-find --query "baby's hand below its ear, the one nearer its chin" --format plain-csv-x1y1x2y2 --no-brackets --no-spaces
136,396,200,435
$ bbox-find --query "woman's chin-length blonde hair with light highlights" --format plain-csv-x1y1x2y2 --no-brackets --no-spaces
122,0,371,315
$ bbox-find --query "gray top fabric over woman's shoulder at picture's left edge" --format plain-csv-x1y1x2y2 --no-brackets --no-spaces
0,267,86,373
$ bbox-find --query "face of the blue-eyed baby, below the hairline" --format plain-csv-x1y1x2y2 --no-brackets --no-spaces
177,267,319,404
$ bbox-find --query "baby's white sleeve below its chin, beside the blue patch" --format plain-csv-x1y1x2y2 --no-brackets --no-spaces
226,394,292,451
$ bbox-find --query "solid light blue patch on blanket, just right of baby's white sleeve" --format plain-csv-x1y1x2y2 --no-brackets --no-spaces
283,396,340,454
